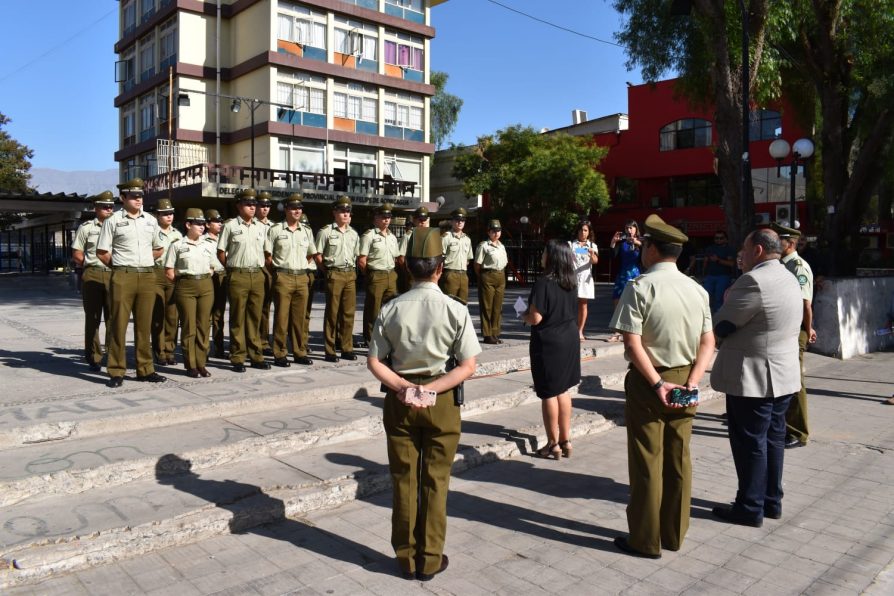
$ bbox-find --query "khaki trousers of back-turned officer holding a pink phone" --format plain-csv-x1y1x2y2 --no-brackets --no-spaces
383,380,460,573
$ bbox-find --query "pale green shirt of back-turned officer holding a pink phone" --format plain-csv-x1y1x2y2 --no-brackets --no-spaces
369,281,481,377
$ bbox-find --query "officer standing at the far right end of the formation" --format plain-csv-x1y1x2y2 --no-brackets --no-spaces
473,219,509,344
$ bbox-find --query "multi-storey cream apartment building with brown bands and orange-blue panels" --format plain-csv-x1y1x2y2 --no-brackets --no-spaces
115,0,446,214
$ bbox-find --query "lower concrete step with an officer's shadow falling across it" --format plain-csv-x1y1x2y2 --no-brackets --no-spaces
0,356,713,587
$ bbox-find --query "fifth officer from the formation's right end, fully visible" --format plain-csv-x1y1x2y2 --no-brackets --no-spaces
314,196,360,362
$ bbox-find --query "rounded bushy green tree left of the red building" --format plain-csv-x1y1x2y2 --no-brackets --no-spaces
453,125,609,235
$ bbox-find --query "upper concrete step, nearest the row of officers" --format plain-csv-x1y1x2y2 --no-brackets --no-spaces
0,342,623,450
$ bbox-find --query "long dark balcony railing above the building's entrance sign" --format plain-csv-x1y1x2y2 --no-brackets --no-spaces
146,163,421,197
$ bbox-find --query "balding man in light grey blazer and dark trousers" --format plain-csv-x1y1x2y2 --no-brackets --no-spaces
711,230,803,528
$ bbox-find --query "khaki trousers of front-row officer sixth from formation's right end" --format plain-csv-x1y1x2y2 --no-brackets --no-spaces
273,271,308,358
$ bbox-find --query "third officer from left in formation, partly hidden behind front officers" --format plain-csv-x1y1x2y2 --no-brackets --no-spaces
152,199,183,364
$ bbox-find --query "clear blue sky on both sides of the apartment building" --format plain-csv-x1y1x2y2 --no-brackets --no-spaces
0,0,641,170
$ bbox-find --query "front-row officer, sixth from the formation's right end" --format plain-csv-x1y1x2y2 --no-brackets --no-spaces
264,193,316,367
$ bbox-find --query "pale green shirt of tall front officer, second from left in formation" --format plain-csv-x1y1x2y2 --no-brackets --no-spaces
96,209,163,267
